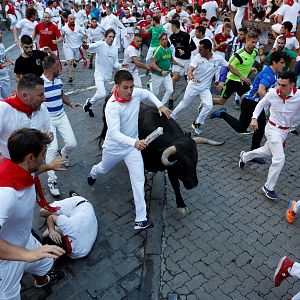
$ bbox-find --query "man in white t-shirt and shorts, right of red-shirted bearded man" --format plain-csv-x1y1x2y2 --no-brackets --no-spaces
61,15,87,83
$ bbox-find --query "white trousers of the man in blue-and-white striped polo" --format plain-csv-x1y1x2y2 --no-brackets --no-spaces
46,112,77,182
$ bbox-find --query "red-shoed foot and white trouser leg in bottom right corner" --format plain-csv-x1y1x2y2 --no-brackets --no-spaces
273,256,300,300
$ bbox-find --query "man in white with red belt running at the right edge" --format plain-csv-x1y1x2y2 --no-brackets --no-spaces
239,71,300,200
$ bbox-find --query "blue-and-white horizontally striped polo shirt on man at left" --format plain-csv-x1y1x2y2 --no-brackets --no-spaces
41,74,64,117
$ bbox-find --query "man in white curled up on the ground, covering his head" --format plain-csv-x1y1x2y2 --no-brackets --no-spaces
40,191,98,259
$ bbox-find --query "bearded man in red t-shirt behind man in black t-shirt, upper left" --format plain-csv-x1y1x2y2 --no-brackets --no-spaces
32,13,63,55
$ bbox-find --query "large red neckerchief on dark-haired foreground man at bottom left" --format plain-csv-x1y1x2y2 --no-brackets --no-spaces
0,158,59,213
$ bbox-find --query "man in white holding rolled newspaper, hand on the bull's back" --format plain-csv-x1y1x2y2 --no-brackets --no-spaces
88,70,171,229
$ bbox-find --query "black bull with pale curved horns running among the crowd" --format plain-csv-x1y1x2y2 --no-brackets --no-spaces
99,102,224,214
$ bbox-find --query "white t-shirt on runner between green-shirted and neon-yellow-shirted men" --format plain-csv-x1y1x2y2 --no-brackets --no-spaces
187,53,228,90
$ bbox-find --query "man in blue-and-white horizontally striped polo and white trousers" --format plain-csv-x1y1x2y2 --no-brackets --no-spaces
41,54,81,197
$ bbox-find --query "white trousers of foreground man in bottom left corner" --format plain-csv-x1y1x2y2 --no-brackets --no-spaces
0,234,53,300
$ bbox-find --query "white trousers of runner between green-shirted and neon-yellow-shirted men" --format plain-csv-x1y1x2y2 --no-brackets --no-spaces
171,81,213,124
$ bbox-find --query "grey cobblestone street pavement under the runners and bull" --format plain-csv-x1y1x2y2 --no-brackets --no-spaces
4,31,300,300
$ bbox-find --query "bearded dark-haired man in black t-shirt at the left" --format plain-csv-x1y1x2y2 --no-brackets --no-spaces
14,35,47,82
